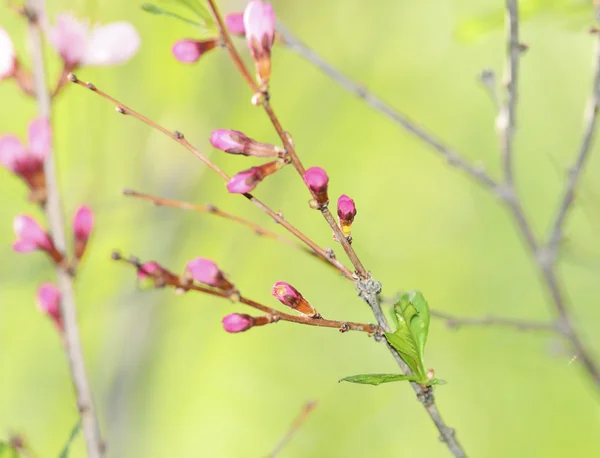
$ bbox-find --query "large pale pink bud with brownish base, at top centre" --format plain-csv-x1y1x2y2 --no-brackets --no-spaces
244,0,275,86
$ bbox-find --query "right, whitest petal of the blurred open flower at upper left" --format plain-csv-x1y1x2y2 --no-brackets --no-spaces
81,22,141,65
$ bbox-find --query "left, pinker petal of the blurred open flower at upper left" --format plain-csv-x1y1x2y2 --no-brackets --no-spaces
48,13,89,68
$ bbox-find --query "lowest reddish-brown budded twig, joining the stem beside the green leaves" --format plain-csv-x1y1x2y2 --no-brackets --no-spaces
112,252,381,336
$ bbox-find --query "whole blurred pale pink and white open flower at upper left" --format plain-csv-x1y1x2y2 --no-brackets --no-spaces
48,13,140,70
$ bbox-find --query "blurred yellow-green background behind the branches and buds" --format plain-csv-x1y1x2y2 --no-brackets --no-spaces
0,0,600,458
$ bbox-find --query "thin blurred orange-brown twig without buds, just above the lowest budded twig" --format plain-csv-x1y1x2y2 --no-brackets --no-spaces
123,189,335,268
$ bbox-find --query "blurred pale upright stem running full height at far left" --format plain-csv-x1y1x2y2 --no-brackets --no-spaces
26,0,104,458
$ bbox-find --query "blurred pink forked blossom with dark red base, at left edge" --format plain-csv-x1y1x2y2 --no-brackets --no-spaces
0,117,52,204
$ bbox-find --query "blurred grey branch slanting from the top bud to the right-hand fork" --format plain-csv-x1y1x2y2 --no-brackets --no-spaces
277,23,497,189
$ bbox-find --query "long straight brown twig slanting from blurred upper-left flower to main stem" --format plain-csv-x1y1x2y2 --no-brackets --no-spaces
69,73,353,279
